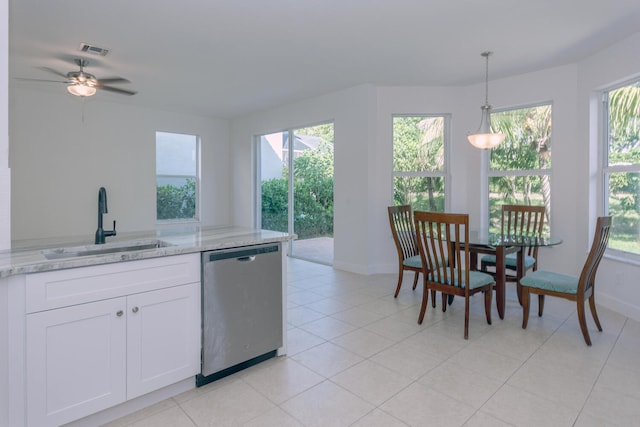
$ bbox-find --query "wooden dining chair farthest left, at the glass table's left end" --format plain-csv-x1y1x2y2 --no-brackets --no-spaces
387,205,422,298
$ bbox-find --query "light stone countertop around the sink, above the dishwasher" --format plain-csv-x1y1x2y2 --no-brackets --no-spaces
0,226,296,278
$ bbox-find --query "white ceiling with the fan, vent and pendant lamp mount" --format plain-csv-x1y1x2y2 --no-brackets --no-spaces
9,0,640,118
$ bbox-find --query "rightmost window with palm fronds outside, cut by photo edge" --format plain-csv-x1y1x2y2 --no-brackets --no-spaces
602,80,640,255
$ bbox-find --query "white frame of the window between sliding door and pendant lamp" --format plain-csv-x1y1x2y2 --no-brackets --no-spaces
390,113,451,212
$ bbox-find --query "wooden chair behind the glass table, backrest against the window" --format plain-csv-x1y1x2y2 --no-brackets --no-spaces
480,205,545,302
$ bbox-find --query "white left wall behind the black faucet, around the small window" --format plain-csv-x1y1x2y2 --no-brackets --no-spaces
9,88,230,241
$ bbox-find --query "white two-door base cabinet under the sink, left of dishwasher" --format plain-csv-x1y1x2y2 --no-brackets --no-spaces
26,254,200,427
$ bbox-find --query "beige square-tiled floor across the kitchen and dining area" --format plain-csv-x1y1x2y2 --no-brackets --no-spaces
102,259,640,427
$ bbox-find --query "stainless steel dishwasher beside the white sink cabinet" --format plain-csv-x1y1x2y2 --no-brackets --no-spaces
196,243,283,386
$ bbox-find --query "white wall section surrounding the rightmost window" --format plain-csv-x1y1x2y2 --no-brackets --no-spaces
576,33,640,320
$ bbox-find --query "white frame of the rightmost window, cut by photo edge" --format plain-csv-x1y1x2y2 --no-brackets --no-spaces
594,76,640,265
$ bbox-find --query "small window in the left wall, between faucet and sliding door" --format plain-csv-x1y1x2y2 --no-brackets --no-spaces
156,132,199,221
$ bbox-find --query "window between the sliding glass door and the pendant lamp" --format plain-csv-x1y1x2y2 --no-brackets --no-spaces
393,115,449,212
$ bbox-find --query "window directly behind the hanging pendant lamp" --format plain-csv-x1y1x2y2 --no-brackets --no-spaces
488,104,551,232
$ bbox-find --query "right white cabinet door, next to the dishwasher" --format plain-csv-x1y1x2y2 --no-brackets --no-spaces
127,283,201,399
